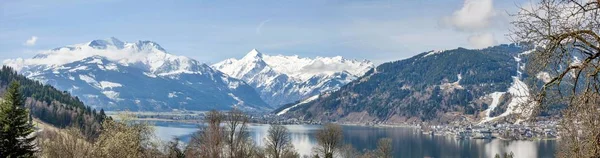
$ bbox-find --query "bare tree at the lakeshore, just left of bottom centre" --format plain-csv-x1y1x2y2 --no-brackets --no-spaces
265,125,299,158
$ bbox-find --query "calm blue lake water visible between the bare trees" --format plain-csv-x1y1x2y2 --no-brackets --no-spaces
154,122,557,158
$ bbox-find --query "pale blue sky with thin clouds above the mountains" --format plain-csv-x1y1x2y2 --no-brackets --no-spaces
0,0,529,64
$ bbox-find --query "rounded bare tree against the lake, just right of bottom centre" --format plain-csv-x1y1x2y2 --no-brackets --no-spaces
316,123,344,158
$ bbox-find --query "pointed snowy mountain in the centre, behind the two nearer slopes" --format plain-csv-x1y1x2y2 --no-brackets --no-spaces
212,49,373,107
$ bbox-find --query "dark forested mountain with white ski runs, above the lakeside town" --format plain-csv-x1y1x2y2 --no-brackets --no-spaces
273,44,542,124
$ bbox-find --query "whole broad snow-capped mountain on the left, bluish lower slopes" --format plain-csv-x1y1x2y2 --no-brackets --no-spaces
4,38,270,111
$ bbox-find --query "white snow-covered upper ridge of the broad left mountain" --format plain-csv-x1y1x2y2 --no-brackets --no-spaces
4,37,196,75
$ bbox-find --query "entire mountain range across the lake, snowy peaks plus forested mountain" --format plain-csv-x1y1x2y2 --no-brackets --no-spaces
4,38,544,124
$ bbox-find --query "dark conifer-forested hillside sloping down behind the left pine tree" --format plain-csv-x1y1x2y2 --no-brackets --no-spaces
0,66,106,137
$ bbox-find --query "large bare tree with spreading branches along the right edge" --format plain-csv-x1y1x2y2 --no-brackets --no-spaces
511,0,600,157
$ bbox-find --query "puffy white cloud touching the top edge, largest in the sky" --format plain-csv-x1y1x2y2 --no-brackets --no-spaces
443,0,496,31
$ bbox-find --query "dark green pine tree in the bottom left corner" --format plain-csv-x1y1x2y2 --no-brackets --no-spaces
0,81,35,158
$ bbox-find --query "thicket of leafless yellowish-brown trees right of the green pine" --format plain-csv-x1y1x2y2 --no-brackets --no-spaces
38,114,166,158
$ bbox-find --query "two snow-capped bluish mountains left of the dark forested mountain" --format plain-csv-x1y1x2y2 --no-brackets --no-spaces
4,37,373,111
